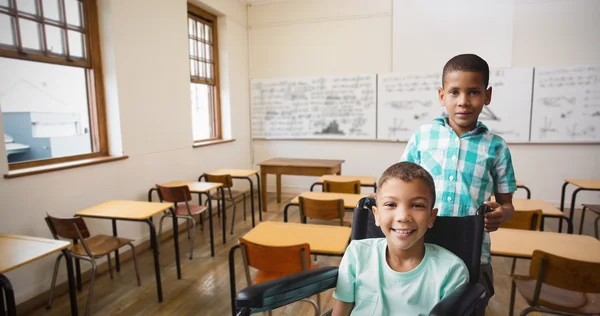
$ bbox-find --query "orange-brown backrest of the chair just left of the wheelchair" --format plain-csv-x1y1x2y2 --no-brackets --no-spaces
240,238,310,275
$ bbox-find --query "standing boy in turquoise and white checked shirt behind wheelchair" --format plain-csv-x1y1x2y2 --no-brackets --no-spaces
401,54,517,315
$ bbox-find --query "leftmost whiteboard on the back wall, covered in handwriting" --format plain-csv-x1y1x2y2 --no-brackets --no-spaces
251,75,377,139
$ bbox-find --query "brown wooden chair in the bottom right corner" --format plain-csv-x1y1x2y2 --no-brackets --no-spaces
509,249,600,316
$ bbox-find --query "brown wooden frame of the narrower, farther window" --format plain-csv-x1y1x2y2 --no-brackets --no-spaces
186,3,223,145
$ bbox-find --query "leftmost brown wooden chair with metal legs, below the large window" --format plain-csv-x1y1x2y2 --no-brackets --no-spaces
45,213,142,315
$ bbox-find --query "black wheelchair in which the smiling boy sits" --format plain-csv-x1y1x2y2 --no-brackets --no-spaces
235,198,485,316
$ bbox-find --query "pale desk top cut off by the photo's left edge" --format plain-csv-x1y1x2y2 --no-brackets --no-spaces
0,234,71,274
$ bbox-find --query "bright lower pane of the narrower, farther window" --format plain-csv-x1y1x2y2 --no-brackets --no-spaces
191,83,215,140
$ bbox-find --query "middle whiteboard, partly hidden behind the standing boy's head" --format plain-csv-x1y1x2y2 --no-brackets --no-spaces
377,68,533,142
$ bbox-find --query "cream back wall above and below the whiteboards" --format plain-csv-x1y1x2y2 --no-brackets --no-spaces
248,0,600,204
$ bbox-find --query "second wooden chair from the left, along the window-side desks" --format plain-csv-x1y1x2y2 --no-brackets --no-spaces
156,184,208,260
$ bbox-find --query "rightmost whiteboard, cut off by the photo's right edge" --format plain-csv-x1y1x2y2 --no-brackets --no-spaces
531,65,600,142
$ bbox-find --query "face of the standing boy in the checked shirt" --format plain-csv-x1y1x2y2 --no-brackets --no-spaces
438,71,492,136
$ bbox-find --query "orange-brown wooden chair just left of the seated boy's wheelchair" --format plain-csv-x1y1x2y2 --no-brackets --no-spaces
239,238,321,316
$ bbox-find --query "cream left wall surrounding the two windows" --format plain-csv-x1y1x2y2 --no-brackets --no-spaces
0,0,251,302
